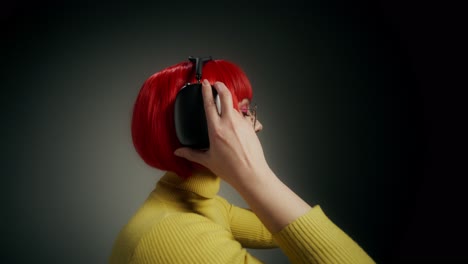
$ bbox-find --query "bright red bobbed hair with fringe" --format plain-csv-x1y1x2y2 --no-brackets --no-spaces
132,60,252,178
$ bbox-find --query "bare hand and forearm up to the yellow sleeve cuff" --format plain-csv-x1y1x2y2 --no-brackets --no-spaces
175,80,310,233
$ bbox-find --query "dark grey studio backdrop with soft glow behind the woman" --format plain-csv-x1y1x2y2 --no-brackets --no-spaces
0,1,466,263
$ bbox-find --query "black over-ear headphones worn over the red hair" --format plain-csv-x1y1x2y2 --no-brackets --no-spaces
174,56,221,149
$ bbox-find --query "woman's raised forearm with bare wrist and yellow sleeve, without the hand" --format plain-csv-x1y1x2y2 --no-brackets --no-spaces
232,168,374,263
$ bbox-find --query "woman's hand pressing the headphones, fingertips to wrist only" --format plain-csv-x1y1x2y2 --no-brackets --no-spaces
175,80,269,185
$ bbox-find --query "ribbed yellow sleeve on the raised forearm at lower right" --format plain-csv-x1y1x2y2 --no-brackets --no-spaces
273,206,374,264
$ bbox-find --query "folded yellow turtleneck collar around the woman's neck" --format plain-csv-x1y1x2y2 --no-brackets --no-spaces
159,172,221,198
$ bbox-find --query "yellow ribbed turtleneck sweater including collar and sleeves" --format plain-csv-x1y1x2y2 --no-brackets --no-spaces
109,173,373,264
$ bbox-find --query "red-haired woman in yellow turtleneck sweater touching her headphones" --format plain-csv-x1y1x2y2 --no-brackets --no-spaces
110,60,373,263
